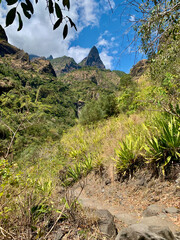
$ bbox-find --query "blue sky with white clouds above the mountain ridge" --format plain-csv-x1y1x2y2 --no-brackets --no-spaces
0,0,145,73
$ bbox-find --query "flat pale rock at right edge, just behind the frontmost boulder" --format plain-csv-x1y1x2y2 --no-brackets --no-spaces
139,214,180,233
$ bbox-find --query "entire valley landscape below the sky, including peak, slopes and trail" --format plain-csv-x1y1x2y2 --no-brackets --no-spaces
0,19,180,240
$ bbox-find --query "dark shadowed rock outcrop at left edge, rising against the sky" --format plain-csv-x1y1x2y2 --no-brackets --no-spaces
0,25,19,57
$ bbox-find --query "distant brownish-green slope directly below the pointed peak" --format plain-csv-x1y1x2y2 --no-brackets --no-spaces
60,67,120,101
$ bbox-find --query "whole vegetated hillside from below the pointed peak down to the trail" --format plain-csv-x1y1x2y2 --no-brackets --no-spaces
0,7,180,240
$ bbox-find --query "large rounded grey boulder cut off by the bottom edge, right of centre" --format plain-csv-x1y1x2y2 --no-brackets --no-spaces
115,224,176,240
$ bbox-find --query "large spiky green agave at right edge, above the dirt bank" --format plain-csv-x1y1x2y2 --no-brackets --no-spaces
146,118,180,175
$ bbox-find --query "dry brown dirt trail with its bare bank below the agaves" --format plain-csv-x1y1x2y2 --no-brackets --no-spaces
73,170,180,230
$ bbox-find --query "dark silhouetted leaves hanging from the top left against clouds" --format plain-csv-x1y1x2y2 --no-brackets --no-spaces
3,0,77,39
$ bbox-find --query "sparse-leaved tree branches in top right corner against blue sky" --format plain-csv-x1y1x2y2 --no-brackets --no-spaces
127,0,180,57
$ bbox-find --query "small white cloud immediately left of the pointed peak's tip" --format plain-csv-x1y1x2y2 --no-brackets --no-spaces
67,46,90,63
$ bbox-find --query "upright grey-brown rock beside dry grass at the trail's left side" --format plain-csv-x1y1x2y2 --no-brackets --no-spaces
95,209,117,237
